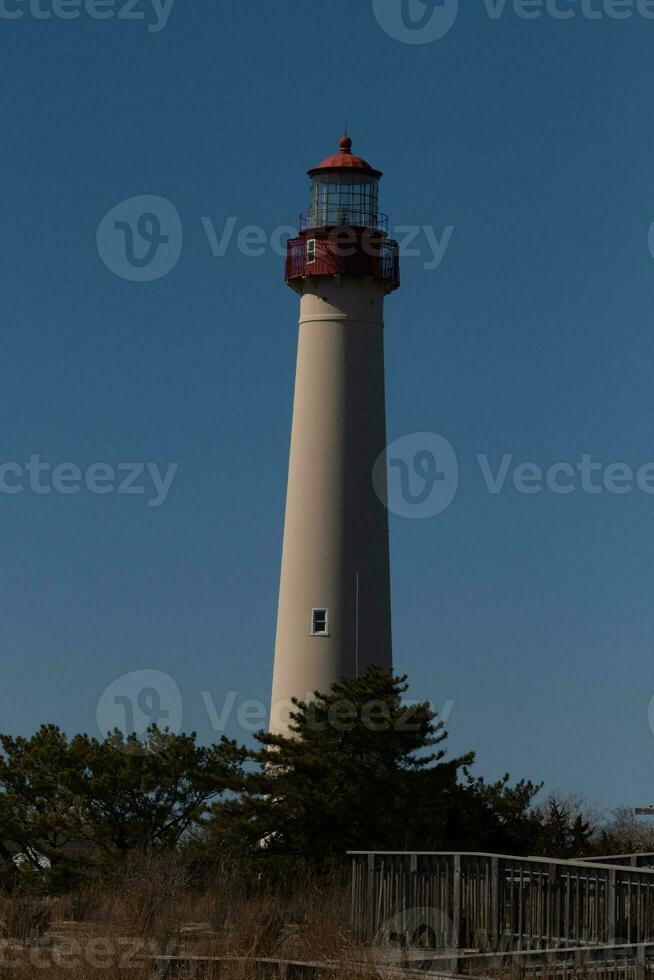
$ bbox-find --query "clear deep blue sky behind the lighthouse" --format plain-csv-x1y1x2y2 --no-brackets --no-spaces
0,0,654,808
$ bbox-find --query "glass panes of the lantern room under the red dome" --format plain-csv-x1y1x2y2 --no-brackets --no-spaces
308,173,379,228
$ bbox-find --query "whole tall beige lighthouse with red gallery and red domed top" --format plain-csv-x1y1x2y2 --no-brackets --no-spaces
270,135,400,734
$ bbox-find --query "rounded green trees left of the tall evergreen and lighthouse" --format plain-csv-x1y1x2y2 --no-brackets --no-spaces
0,725,245,869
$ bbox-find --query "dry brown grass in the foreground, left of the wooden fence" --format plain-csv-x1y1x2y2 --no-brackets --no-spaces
0,856,382,980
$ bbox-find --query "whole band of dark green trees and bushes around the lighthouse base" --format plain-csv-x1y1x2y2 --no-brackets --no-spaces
0,667,596,890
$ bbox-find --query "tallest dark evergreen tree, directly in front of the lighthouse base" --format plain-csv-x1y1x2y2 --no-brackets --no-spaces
209,667,473,862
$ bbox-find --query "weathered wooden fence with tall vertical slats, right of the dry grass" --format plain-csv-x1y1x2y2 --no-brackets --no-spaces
352,852,654,951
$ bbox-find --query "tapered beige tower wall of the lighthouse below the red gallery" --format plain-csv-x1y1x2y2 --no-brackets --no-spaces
271,276,392,731
